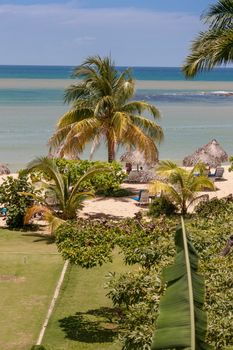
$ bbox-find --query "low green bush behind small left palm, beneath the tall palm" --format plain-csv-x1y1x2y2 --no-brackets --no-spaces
33,158,127,196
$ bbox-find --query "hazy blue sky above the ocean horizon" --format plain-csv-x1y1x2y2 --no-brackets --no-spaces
0,0,214,66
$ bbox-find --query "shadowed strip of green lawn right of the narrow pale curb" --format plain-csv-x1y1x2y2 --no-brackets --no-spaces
43,254,131,350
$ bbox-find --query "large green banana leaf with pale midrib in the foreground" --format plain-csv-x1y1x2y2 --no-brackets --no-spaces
151,218,213,350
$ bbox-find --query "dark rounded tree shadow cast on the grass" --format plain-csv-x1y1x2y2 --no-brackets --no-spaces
59,307,118,343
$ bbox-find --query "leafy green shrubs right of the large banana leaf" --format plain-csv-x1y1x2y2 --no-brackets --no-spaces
187,216,233,350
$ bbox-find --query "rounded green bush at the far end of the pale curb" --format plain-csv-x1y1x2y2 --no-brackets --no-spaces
55,220,115,268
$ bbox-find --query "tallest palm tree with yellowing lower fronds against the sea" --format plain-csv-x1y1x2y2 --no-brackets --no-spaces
49,56,163,162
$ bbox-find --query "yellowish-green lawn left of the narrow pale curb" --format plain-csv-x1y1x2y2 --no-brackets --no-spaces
0,229,63,350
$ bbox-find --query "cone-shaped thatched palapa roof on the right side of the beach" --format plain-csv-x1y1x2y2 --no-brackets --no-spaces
183,139,228,168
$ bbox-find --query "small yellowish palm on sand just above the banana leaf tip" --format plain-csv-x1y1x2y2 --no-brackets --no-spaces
150,161,215,214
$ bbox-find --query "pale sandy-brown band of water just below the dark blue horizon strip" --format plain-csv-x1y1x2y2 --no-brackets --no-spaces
0,78,233,91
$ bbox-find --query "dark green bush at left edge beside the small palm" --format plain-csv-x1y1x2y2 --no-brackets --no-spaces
0,174,35,228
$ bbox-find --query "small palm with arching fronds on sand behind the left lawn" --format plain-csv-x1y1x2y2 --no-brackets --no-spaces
21,157,110,231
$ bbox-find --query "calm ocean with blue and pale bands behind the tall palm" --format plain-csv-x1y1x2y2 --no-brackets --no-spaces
0,66,233,171
